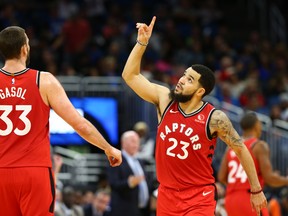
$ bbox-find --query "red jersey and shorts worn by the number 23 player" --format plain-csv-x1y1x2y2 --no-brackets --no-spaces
156,101,216,216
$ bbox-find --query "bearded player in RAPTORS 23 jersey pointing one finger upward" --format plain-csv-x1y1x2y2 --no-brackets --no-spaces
122,17,267,216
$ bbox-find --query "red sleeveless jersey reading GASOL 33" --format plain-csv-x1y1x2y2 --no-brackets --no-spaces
0,68,51,167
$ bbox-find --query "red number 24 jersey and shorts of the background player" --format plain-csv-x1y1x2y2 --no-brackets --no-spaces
225,138,269,216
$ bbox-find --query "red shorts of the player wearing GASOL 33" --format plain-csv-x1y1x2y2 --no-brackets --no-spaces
0,167,55,216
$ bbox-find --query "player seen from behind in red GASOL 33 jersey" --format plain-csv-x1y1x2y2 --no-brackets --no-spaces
0,26,122,216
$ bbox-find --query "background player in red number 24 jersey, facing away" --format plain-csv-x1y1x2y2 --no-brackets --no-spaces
218,112,288,216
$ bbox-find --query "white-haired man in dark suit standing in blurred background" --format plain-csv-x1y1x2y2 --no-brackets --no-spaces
108,131,150,216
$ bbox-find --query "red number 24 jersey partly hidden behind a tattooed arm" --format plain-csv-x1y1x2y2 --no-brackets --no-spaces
226,138,264,194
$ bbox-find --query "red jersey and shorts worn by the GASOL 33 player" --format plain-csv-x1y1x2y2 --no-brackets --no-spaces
0,68,55,216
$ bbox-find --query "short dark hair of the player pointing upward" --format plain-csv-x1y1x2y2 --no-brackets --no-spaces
191,64,215,97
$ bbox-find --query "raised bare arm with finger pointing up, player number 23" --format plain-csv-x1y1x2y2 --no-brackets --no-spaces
122,16,169,105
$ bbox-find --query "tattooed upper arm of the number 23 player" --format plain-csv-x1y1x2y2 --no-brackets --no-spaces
210,111,243,147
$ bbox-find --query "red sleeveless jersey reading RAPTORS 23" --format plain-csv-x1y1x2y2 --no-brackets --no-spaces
156,101,216,189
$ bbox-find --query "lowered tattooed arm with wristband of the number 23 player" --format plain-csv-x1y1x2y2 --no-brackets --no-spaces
209,110,267,215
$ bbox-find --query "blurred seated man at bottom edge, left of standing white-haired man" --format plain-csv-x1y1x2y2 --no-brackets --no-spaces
84,188,111,216
